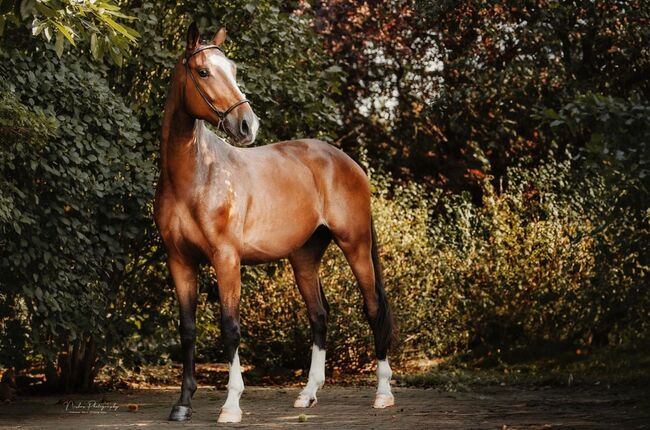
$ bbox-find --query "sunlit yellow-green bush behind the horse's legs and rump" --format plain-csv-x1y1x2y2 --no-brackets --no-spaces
186,161,650,370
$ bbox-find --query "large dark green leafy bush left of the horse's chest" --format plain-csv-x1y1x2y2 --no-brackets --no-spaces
0,42,153,389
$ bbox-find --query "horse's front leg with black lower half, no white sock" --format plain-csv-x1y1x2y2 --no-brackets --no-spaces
169,259,197,421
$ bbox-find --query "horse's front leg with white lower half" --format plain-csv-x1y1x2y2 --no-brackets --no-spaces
213,250,244,423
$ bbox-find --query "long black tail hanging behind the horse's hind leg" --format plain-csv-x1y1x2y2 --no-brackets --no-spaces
370,218,397,360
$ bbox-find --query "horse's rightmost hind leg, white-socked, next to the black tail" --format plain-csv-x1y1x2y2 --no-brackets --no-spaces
336,223,395,409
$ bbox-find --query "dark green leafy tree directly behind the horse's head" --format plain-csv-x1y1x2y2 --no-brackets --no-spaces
112,0,341,149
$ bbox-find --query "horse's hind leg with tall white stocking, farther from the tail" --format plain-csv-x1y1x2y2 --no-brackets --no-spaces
289,227,331,408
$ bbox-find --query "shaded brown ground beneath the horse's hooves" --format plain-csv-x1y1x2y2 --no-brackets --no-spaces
0,386,650,430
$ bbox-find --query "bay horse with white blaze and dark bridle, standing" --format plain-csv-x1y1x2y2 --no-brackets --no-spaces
154,23,394,422
